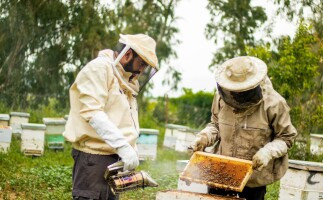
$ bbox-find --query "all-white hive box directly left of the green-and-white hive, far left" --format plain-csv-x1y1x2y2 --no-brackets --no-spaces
21,123,46,156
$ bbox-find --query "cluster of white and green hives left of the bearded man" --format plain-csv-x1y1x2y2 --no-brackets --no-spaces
0,112,67,156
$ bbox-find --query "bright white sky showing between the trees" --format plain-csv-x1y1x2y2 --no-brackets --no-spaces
151,0,296,97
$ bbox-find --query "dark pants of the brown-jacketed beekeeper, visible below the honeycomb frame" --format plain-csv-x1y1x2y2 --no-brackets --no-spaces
209,186,266,200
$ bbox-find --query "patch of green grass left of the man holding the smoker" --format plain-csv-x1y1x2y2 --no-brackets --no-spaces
0,139,73,199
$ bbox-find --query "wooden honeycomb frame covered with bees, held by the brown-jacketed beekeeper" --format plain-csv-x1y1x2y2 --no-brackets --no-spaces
180,152,252,192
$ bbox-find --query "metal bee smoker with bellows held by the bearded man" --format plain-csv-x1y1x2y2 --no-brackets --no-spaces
104,161,158,194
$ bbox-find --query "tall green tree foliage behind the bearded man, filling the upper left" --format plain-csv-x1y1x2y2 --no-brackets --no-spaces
0,0,182,109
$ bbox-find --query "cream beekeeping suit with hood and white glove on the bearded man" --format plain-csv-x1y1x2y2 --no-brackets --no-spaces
64,34,158,170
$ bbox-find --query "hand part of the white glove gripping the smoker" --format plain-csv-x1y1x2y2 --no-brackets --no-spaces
117,144,139,171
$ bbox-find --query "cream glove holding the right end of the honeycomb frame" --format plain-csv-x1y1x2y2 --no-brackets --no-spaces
252,140,288,171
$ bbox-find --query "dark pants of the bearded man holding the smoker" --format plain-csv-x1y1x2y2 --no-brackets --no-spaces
72,149,119,200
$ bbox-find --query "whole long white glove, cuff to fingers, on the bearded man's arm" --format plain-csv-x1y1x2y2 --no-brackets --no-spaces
89,111,139,170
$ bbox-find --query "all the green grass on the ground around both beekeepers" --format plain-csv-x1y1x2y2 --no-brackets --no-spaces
0,139,279,200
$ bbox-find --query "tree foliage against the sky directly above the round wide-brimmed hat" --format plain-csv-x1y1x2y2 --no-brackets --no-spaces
206,0,267,67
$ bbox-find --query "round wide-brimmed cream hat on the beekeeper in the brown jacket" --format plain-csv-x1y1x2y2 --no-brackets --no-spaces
215,56,267,92
